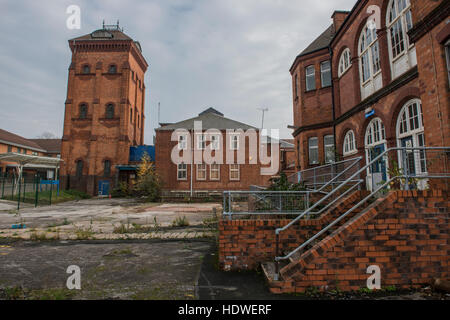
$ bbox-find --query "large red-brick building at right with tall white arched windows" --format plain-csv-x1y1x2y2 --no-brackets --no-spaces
290,0,450,188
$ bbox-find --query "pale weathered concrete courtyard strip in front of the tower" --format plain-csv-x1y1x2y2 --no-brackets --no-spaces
0,199,221,240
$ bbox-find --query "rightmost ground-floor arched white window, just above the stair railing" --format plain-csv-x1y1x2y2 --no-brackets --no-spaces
397,99,427,175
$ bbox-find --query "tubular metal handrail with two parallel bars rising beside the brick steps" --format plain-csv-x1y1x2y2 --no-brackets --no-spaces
275,147,450,277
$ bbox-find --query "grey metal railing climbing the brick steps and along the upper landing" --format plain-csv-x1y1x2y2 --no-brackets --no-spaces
275,147,450,279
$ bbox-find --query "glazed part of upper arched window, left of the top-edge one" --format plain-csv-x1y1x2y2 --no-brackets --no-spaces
359,25,381,84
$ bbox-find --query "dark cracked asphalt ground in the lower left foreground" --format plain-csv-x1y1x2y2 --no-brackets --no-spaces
0,240,212,300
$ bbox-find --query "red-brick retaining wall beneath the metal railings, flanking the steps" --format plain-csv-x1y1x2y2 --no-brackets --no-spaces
220,191,450,293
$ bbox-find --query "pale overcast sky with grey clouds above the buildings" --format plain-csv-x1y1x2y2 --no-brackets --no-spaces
0,0,356,144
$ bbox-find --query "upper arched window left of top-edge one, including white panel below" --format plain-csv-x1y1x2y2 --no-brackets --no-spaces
358,24,382,99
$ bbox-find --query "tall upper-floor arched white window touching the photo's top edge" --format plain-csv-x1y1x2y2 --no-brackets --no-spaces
386,0,417,79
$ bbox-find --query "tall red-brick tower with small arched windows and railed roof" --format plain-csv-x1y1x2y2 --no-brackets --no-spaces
61,25,148,195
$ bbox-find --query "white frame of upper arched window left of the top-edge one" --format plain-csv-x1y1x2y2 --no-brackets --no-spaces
358,25,381,86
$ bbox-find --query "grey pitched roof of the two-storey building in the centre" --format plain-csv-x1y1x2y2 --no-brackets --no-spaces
155,108,259,131
